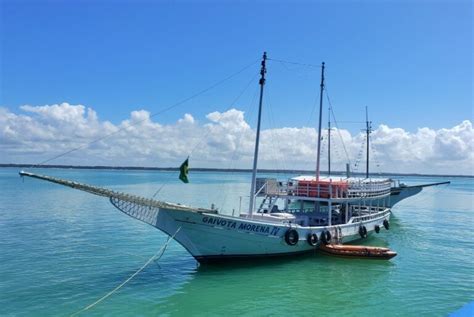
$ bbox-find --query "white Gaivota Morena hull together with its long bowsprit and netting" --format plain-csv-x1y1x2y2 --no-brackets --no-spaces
20,171,390,262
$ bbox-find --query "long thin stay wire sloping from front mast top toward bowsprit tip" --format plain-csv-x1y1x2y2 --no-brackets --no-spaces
35,60,258,167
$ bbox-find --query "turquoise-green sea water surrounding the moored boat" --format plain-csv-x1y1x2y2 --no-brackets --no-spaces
0,168,474,316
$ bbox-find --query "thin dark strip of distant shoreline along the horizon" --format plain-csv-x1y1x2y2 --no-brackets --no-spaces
0,164,474,178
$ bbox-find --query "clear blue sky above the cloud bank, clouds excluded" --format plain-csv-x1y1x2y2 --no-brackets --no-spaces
0,0,473,131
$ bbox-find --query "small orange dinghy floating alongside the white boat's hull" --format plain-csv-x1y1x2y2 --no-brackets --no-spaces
319,244,397,260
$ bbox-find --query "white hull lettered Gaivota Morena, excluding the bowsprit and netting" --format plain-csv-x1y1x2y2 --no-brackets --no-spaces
155,209,390,262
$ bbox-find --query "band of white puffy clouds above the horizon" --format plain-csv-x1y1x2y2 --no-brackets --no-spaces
0,103,474,175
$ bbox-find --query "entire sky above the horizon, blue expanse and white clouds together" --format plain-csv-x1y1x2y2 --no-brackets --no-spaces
0,0,474,175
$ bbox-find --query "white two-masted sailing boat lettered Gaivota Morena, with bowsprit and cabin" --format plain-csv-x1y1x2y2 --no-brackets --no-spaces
20,53,398,263
